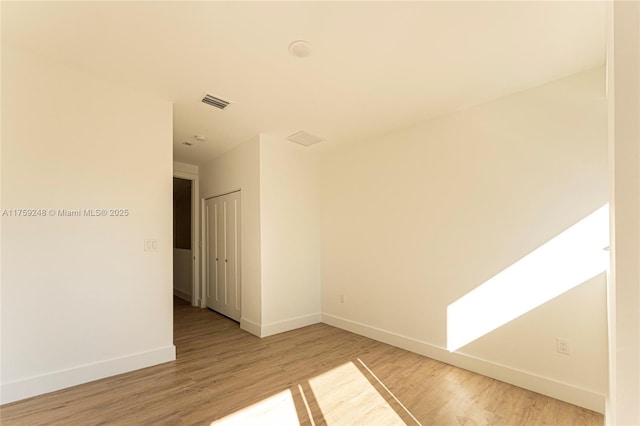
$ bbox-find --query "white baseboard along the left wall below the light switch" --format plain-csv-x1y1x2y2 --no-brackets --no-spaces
0,345,176,404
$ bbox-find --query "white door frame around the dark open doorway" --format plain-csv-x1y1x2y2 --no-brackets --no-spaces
173,162,204,307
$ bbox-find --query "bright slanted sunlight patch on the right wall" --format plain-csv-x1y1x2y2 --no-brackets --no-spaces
447,204,609,351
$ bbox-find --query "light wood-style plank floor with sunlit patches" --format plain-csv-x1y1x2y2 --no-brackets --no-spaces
0,301,604,426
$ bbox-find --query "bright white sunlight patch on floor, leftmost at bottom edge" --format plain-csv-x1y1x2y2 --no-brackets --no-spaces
211,389,300,426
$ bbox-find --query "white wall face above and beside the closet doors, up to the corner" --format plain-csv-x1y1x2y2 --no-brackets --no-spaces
200,136,262,336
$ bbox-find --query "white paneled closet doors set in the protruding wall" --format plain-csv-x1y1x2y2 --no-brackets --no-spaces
205,192,241,321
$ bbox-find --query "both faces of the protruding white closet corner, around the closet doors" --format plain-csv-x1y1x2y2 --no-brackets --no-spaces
200,135,320,337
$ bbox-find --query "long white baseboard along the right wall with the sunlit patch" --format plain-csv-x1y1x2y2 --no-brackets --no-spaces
322,313,605,414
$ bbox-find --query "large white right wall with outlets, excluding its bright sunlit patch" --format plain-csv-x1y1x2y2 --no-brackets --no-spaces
321,69,608,411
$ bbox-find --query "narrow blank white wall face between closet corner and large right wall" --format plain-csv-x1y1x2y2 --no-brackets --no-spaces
260,135,320,336
